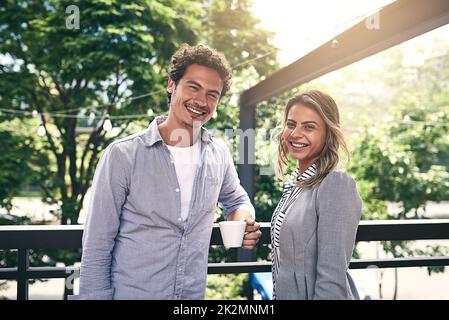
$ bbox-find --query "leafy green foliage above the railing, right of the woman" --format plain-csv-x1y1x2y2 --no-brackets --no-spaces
349,108,449,219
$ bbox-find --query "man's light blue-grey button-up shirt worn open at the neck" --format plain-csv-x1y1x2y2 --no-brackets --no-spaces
71,118,254,299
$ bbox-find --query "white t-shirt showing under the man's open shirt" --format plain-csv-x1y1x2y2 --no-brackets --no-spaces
167,141,201,221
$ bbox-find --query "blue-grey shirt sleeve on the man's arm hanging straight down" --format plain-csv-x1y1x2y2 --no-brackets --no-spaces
70,144,129,300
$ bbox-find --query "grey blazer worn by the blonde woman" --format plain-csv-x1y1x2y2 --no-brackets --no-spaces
276,171,362,300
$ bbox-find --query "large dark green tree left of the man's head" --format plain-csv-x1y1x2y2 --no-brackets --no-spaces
0,0,203,224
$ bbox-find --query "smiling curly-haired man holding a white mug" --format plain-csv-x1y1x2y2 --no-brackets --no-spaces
71,45,261,299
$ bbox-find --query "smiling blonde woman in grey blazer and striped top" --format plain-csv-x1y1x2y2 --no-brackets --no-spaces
271,90,362,299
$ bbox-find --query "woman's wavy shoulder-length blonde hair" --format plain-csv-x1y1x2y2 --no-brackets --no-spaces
276,90,350,188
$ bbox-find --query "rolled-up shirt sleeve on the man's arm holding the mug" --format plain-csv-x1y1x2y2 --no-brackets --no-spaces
218,146,255,219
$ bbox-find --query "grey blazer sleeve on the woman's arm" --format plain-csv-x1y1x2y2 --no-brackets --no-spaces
313,172,362,300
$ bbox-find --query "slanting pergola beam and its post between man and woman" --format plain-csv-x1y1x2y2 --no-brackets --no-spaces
239,0,449,205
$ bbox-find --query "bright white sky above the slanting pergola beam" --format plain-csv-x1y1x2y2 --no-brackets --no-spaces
253,0,394,65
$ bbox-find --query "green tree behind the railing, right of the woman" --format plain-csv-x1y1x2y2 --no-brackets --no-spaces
349,105,449,297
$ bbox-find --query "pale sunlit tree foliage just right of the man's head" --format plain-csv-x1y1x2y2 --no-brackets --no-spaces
199,0,278,132
